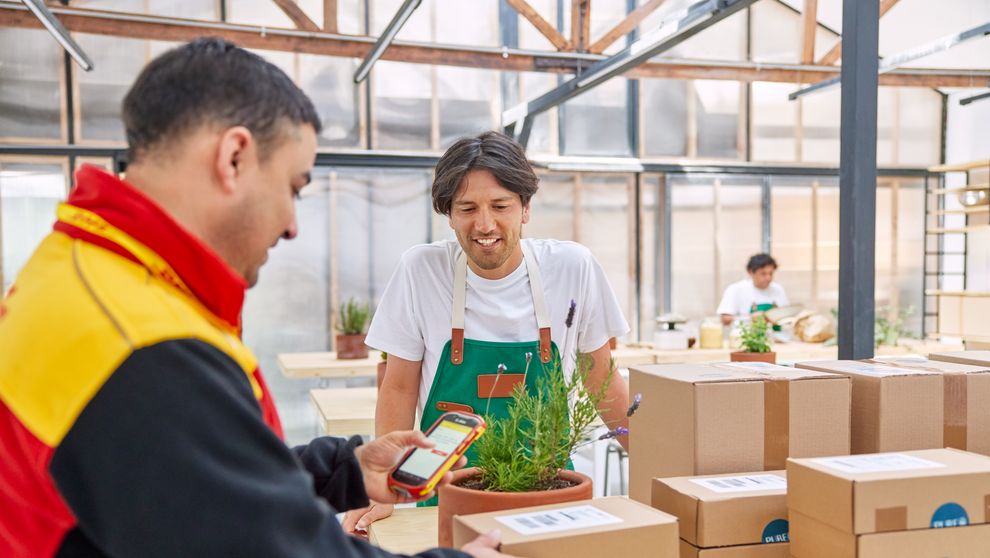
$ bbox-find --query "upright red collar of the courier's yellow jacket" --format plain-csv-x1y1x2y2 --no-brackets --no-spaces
55,165,247,330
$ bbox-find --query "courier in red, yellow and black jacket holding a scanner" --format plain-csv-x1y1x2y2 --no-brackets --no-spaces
0,39,503,558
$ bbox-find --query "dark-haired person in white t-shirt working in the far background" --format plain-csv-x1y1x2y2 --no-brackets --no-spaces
717,254,790,325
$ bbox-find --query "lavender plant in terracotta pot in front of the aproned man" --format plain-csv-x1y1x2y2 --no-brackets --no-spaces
438,303,640,546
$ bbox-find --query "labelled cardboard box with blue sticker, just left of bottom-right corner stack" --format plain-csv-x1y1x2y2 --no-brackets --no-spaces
653,471,787,548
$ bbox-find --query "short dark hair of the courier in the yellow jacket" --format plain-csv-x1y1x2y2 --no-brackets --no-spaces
122,37,322,161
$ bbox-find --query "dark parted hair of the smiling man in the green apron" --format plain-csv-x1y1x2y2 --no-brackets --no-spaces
433,132,540,215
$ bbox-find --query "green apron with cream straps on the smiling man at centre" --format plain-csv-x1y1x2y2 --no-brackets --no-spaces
418,242,560,506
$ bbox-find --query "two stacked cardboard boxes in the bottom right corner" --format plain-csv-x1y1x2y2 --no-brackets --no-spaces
787,449,990,558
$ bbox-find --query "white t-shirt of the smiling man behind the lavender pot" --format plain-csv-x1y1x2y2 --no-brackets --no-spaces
365,239,629,415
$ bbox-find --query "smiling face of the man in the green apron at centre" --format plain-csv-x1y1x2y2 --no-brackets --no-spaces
450,169,529,279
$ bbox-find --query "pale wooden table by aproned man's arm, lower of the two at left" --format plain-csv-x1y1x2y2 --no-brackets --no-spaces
309,387,378,436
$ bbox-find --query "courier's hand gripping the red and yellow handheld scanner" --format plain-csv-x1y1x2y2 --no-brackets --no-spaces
354,430,467,510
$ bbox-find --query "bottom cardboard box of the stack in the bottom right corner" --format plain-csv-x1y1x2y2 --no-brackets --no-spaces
790,511,990,558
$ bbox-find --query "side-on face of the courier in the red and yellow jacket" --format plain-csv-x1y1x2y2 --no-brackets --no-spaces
217,124,316,286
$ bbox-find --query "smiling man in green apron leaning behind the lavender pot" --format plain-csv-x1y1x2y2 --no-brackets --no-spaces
344,132,629,529
